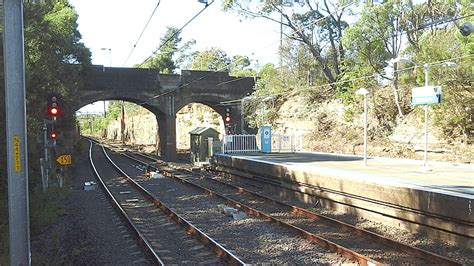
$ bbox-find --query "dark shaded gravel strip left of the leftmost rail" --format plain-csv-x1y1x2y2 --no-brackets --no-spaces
31,141,148,265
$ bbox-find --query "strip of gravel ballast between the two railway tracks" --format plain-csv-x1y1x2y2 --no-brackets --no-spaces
108,151,356,265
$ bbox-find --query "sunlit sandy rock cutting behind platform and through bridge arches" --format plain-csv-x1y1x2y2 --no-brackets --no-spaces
107,98,474,163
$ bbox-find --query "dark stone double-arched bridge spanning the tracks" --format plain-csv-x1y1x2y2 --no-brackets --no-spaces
77,65,254,161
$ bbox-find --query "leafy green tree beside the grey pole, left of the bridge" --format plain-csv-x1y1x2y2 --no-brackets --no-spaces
24,0,91,120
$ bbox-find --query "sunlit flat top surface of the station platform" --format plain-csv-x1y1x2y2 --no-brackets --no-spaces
226,152,474,198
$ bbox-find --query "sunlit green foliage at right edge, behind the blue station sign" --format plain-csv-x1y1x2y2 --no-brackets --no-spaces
415,27,474,141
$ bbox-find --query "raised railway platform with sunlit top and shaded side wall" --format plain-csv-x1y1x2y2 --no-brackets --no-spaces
212,152,474,248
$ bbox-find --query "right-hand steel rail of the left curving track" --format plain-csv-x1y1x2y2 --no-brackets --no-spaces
101,145,247,265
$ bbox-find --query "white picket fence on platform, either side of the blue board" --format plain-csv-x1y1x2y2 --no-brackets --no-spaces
222,134,303,153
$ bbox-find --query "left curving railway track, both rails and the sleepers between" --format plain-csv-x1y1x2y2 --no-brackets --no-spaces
89,142,245,265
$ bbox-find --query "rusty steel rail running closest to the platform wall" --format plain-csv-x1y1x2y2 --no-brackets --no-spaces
203,169,460,265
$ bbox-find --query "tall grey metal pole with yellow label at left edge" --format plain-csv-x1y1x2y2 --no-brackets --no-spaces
3,0,31,265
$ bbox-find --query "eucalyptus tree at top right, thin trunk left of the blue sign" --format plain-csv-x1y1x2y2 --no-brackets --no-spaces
342,0,472,116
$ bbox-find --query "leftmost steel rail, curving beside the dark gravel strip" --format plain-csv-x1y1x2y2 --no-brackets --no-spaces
89,139,165,265
